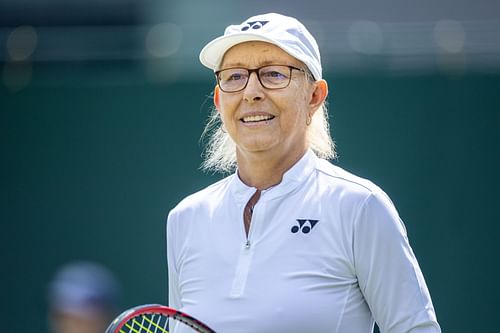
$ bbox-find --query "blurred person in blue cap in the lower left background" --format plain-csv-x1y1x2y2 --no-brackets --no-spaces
48,262,120,333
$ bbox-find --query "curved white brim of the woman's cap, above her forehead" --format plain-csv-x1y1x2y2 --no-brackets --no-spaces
200,33,288,70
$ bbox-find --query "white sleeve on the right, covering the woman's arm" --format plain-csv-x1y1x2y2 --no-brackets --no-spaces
353,191,441,333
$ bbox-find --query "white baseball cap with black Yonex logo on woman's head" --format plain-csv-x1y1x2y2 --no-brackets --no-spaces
200,13,322,80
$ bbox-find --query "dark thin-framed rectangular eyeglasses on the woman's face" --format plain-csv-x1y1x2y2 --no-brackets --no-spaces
215,65,305,93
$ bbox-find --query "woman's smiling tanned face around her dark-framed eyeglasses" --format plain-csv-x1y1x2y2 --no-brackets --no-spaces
214,42,326,163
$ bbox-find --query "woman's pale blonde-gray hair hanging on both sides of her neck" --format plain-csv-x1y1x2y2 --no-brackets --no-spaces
201,98,336,173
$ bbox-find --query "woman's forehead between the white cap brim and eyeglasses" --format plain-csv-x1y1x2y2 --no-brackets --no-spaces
220,41,302,68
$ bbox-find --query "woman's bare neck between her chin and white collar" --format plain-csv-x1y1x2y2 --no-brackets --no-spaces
236,148,307,191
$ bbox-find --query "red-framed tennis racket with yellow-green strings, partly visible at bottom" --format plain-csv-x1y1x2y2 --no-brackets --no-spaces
106,304,215,333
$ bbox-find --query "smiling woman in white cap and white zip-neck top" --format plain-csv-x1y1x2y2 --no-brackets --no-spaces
167,14,440,333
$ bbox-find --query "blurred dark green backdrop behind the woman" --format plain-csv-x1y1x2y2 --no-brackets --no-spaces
0,3,500,332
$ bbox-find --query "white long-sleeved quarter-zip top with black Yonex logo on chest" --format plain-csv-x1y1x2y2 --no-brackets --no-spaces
167,151,440,333
